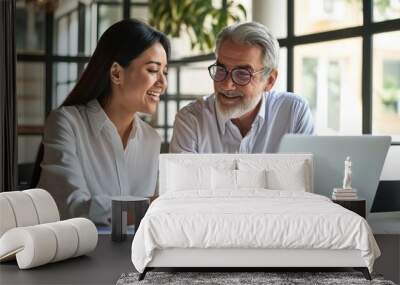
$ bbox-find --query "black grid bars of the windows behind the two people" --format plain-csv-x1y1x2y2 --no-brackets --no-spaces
17,0,400,142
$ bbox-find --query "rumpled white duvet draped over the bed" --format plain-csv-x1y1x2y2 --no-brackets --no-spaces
132,189,380,272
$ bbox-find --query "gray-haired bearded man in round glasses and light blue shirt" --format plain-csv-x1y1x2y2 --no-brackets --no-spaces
170,22,314,153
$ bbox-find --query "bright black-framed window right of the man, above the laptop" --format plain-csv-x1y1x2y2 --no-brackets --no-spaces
280,0,400,140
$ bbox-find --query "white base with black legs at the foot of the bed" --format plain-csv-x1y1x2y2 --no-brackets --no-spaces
139,248,371,280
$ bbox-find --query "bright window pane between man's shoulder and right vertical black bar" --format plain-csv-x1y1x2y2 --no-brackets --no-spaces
293,38,362,134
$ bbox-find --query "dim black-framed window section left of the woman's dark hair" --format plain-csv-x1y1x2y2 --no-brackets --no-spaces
15,0,148,188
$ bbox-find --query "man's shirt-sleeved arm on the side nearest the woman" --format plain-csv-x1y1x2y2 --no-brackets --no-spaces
169,110,198,153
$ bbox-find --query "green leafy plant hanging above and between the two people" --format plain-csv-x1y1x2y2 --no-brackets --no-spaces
149,0,247,57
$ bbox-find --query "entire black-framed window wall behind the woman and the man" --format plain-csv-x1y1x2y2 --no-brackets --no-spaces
15,0,400,186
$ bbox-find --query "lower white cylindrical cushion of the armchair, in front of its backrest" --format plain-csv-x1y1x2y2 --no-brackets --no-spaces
0,218,98,269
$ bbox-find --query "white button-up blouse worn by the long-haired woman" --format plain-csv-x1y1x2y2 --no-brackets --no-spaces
38,100,161,224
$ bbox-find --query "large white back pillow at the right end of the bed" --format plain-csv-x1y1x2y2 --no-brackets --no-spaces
267,162,308,192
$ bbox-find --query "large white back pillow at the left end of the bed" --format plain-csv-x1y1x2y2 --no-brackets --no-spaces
167,163,211,191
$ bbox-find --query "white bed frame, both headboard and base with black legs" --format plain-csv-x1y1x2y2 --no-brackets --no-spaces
139,154,371,280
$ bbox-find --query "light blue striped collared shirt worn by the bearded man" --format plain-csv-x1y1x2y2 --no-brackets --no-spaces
170,91,314,153
